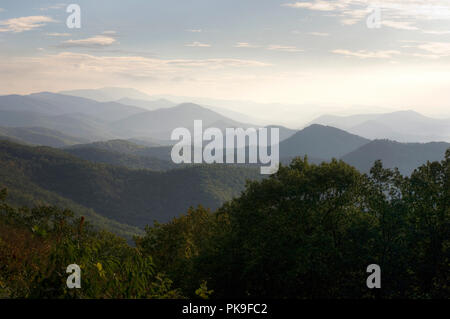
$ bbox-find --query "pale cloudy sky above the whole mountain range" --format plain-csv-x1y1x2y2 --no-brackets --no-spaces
0,0,450,122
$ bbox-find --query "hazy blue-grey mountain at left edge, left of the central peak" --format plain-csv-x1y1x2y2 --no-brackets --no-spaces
0,92,153,141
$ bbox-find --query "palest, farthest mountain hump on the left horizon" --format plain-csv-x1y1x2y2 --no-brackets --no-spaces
59,87,152,102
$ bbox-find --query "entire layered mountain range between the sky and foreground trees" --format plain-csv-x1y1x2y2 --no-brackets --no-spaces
0,89,450,238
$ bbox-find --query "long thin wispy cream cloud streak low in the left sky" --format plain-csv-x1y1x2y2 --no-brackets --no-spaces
0,52,270,82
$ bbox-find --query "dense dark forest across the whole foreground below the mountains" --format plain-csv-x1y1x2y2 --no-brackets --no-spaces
0,150,450,299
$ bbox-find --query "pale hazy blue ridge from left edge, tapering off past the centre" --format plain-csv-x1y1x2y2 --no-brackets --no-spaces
0,92,262,144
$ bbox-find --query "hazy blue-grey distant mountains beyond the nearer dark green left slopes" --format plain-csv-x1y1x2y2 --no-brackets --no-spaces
0,88,450,174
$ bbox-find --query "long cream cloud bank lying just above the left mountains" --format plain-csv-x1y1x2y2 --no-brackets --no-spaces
0,52,270,89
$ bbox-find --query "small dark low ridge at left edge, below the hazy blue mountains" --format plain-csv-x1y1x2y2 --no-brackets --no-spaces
0,127,88,147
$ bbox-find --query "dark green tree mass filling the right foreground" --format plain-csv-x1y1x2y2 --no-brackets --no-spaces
137,150,450,298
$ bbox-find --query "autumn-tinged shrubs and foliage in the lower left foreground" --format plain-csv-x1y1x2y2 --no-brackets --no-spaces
0,191,181,298
